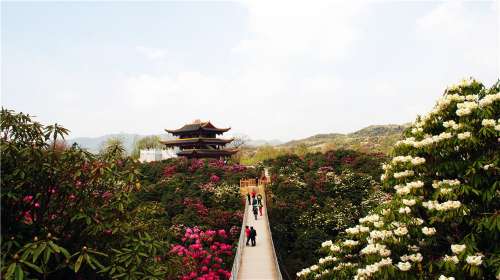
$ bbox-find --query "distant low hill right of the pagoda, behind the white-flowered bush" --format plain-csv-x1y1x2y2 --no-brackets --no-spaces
280,124,409,153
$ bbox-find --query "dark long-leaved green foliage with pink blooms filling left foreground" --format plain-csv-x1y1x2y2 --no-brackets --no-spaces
0,109,180,279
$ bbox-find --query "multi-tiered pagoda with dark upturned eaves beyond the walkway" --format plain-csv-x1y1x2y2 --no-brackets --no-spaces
161,120,238,158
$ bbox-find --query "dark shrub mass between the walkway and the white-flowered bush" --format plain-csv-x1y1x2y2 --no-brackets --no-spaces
264,150,384,274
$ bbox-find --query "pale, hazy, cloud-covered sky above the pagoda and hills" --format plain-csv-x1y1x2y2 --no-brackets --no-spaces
0,0,500,141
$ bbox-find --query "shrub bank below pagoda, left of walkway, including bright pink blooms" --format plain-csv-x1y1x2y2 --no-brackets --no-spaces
137,158,257,279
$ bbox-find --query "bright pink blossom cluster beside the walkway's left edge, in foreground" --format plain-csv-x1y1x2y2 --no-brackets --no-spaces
170,227,233,280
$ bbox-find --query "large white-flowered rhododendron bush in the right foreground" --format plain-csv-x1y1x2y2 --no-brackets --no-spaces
297,79,500,279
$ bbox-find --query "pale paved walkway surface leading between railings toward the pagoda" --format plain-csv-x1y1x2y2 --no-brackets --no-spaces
238,186,278,280
